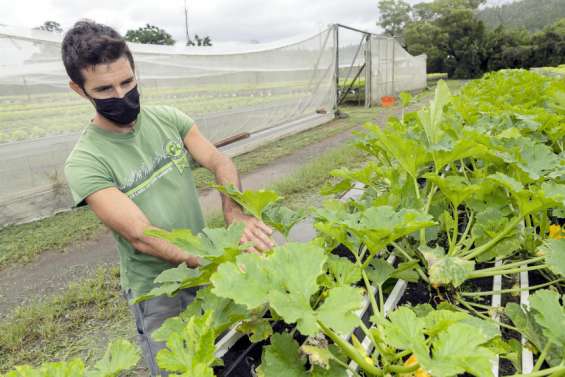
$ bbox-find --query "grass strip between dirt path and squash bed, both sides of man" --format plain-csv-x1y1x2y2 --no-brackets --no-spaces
0,132,366,375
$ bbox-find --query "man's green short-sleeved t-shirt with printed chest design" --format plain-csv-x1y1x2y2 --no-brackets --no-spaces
65,106,204,296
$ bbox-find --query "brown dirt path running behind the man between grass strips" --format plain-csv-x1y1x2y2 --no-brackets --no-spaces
0,103,424,319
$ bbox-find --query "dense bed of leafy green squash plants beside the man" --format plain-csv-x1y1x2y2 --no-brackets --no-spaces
2,71,565,377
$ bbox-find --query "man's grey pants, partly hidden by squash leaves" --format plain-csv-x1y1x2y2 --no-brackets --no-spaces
125,288,198,377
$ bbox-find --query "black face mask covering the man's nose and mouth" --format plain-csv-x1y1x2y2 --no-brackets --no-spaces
85,85,140,126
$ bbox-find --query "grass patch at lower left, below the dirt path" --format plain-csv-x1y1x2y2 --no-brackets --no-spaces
0,267,134,370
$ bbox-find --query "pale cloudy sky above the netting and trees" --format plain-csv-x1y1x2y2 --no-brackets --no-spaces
0,0,504,43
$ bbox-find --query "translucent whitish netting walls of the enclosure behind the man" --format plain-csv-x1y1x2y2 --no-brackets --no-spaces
0,26,426,226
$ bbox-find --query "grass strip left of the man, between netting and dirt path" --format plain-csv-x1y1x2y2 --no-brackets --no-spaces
0,208,104,270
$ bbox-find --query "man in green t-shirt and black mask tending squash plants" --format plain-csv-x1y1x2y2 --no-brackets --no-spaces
62,21,273,376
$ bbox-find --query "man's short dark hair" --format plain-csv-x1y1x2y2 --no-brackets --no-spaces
61,20,135,89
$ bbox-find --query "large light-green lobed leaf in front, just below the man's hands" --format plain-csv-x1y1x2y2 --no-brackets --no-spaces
211,243,361,335
